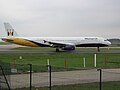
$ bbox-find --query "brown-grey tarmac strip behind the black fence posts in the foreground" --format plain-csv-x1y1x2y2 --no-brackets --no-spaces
11,69,120,88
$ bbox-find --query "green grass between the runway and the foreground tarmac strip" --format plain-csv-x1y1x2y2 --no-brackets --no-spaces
0,48,120,73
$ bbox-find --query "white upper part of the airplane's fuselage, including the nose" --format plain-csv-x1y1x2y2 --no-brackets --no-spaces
13,37,111,47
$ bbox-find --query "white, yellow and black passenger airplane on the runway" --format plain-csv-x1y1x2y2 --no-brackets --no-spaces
2,23,111,52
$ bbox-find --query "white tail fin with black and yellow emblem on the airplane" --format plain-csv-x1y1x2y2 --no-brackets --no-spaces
4,23,18,37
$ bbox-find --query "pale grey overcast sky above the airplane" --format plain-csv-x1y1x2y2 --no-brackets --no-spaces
0,0,120,38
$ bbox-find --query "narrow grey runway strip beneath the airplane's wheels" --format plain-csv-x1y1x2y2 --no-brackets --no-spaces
0,50,120,54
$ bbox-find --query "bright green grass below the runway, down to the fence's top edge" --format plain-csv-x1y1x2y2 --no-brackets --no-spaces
0,53,120,68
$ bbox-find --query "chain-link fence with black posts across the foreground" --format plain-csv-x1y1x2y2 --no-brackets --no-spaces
0,62,120,90
